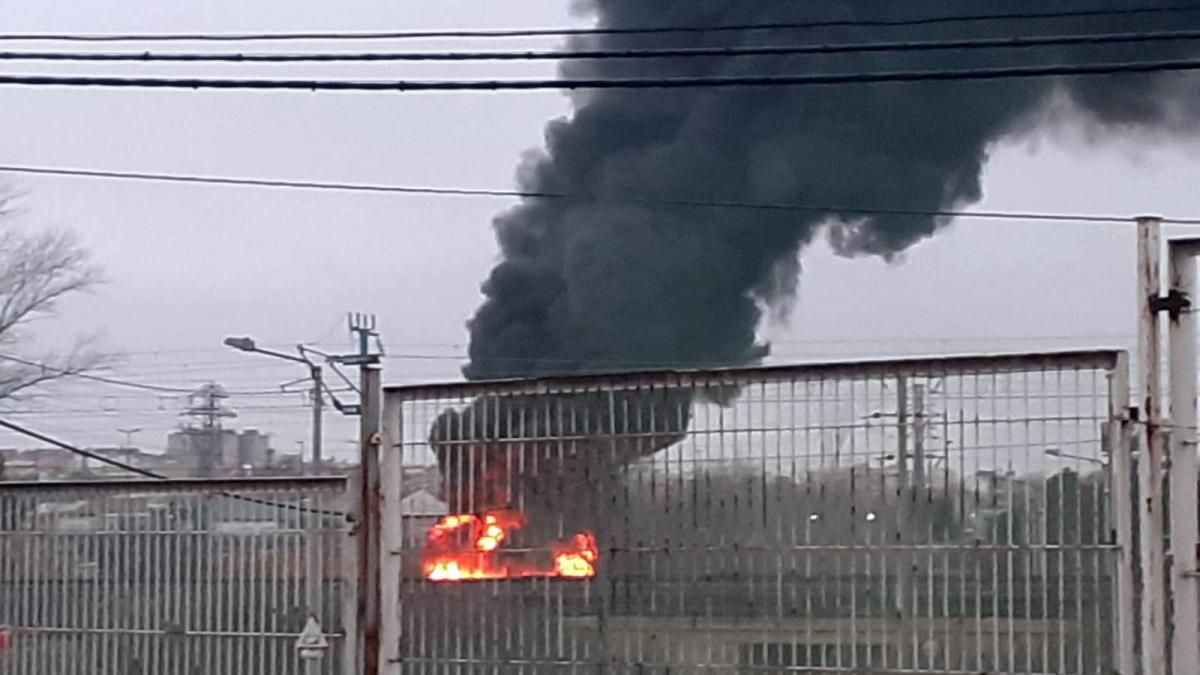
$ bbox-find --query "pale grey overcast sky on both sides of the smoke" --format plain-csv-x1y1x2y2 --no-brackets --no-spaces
0,0,1200,452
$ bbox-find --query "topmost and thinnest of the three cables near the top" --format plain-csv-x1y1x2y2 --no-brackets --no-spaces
0,5,1200,42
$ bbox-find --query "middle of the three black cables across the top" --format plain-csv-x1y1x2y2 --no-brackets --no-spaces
0,30,1200,64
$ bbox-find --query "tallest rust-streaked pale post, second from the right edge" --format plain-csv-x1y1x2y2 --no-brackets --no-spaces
1138,216,1168,675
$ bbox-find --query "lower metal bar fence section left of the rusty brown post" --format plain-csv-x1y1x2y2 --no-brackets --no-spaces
0,478,347,675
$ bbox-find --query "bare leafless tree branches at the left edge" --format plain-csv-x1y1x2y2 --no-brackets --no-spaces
0,196,108,401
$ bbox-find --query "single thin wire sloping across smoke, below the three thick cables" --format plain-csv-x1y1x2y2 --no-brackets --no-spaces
0,165,1200,225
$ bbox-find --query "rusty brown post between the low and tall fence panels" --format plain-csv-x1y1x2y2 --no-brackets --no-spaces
355,365,383,675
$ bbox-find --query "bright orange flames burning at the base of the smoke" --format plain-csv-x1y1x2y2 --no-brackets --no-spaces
424,512,600,581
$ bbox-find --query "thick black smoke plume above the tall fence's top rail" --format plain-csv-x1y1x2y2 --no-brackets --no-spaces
466,0,1200,378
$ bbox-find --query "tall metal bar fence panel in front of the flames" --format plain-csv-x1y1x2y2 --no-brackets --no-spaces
384,352,1133,674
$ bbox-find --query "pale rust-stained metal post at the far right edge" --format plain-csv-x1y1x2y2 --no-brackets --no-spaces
1166,239,1200,673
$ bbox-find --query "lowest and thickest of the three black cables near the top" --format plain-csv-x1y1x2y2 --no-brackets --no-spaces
0,59,1200,94
